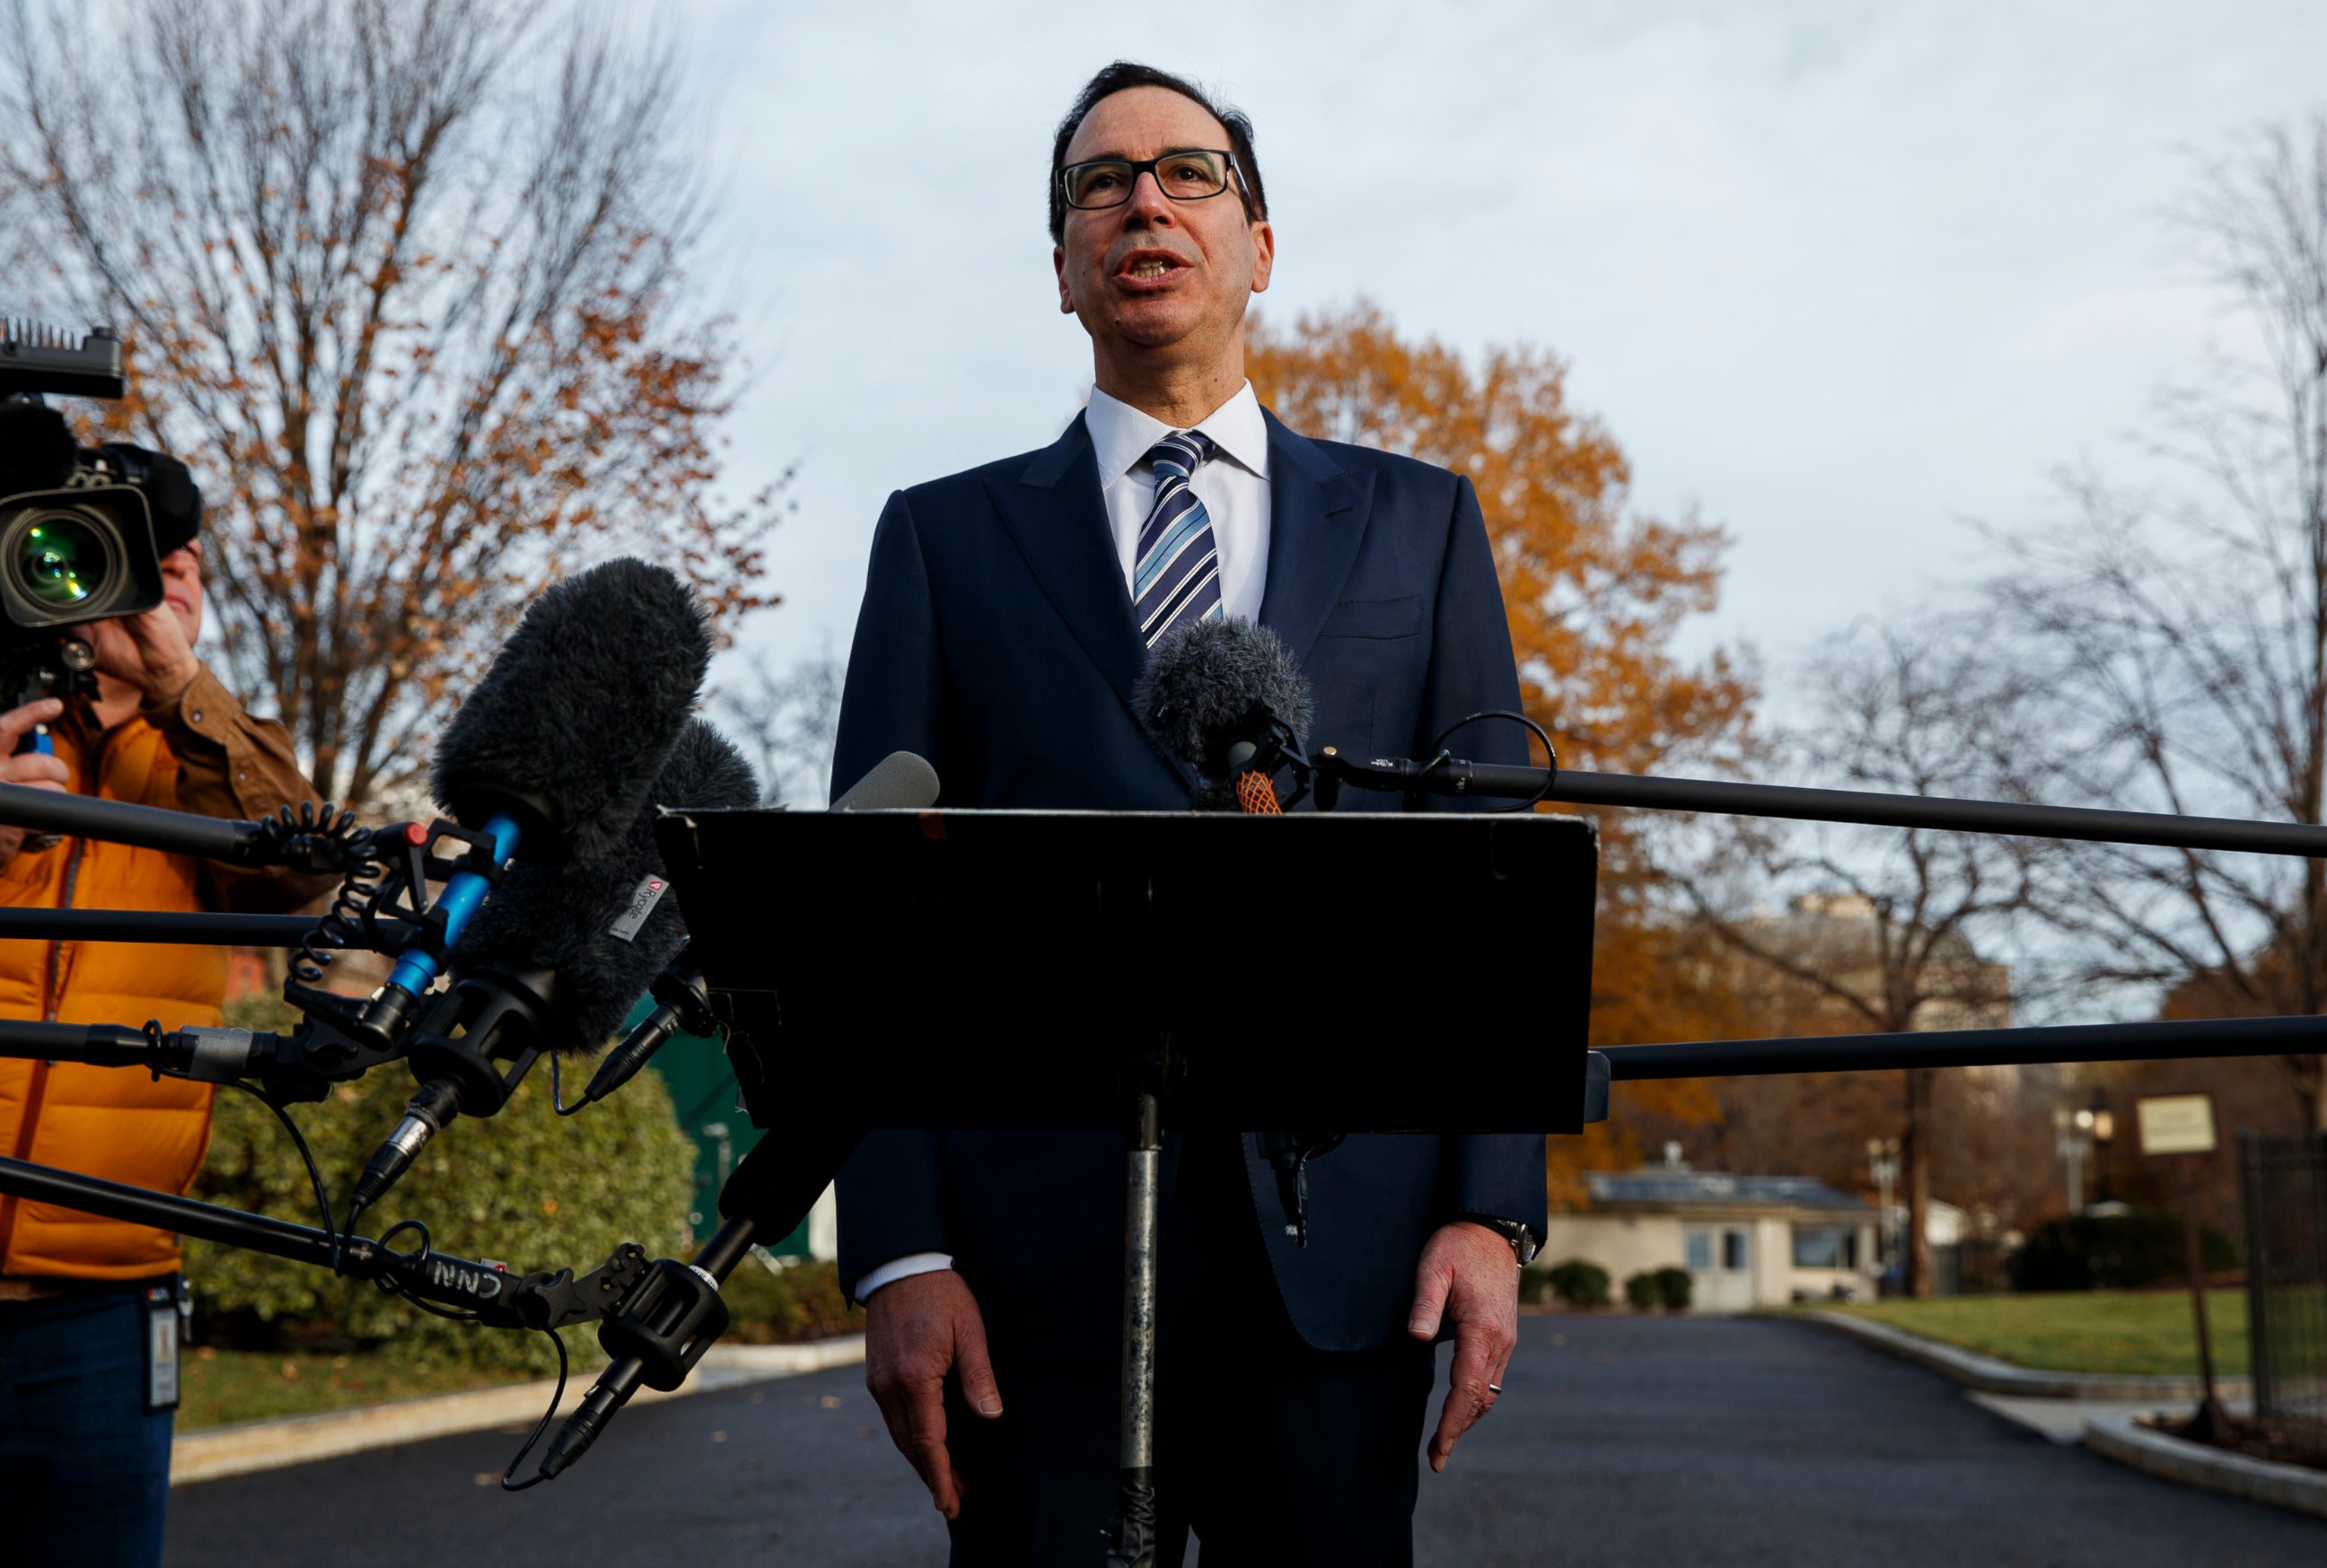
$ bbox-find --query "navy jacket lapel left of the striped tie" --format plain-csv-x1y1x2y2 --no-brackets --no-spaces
987,414,1147,705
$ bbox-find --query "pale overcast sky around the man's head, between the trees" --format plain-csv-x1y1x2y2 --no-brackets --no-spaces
677,0,2327,706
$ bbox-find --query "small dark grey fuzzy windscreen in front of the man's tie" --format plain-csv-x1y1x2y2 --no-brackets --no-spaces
1131,618,1313,786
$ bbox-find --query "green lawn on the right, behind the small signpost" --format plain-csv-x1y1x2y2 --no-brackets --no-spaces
1840,1292,2245,1377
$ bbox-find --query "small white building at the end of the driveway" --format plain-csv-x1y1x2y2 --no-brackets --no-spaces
1538,1168,1875,1312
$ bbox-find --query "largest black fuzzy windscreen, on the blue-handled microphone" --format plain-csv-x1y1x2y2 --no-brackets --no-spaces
431,561,712,861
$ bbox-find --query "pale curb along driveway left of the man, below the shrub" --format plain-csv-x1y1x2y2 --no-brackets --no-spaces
170,1333,865,1486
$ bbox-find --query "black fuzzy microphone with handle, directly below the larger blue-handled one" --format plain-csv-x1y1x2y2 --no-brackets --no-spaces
349,719,759,1222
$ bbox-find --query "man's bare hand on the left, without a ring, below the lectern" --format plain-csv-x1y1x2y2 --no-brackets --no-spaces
865,1268,1003,1520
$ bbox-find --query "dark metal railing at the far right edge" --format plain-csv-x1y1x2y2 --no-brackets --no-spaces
2239,1133,2327,1463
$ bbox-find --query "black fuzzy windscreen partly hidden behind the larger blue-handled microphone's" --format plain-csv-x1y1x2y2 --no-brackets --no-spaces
453,719,759,1054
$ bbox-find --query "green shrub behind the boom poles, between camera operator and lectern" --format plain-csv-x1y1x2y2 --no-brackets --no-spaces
186,998,696,1371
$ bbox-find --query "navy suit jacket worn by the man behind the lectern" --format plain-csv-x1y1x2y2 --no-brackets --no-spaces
833,416,1545,1359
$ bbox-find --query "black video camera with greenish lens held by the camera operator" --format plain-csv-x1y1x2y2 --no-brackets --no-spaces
0,321,203,749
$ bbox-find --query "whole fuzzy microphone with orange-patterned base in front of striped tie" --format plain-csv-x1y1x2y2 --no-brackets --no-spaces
1131,617,1313,814
